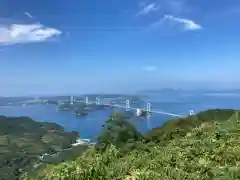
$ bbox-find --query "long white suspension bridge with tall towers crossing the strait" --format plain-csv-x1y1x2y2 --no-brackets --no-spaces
64,96,194,117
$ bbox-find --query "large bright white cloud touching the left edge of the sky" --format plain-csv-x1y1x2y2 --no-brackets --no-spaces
0,24,62,45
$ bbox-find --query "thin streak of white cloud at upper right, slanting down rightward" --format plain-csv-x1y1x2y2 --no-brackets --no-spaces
164,15,202,30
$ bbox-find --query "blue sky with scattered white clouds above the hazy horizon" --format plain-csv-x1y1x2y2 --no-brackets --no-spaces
0,0,240,95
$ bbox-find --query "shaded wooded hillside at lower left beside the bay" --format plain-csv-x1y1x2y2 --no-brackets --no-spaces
0,116,79,180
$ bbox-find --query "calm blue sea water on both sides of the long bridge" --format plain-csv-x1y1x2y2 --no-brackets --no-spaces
0,95,240,140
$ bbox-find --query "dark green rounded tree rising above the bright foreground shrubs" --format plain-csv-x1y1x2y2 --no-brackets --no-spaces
96,113,143,152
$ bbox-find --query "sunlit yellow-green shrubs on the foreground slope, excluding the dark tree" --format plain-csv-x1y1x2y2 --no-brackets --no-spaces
23,111,240,180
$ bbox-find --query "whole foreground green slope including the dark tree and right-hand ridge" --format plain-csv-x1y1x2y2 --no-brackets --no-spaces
22,110,240,180
